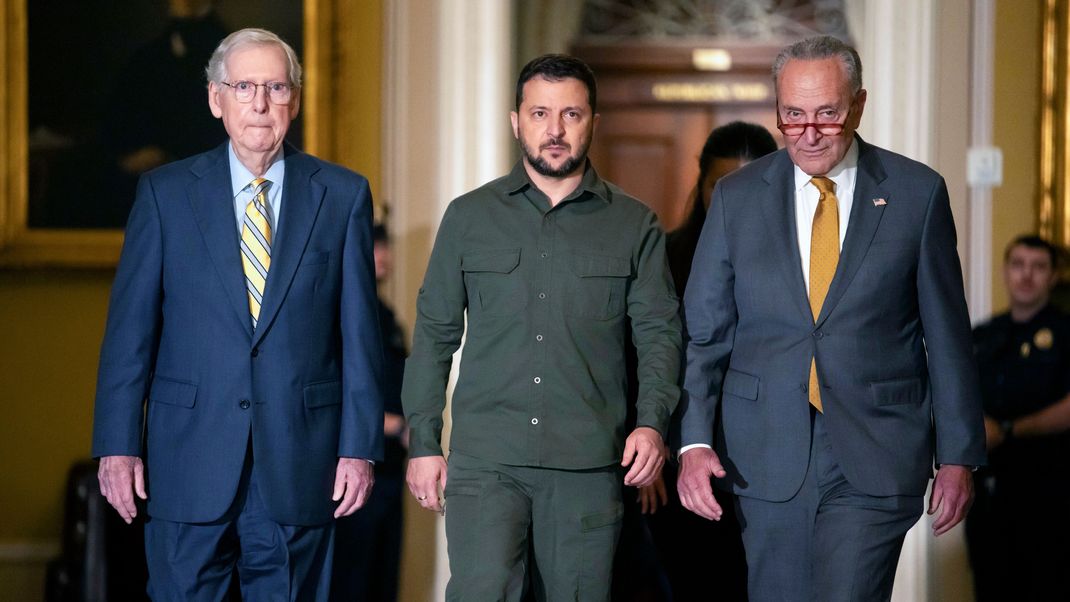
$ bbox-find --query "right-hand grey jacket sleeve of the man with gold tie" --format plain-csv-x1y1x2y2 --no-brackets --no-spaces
917,179,984,466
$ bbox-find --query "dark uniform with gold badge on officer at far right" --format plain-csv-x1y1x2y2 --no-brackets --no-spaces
966,306,1070,600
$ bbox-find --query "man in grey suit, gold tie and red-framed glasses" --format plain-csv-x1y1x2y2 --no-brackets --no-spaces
677,36,984,601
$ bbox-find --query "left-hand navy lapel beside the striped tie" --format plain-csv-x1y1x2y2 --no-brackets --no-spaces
188,142,253,337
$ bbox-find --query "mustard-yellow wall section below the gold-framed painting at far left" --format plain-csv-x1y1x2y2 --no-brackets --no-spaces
0,271,112,532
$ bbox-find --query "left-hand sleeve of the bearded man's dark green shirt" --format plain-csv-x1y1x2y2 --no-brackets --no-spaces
401,203,468,458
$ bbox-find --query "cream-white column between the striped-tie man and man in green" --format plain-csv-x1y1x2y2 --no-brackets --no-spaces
383,0,515,601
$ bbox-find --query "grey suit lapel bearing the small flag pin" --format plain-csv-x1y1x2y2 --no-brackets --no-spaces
816,138,889,326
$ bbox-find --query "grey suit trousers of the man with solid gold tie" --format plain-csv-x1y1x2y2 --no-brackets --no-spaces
736,411,922,602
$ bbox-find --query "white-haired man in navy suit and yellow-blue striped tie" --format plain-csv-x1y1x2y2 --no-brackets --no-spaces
93,29,383,600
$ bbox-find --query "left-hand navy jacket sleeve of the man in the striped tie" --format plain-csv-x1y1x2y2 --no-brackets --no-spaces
92,175,164,458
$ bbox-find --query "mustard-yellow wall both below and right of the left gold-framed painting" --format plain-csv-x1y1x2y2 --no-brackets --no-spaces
0,0,382,600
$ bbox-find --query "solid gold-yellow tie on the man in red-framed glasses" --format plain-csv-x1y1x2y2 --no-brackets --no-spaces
809,176,840,412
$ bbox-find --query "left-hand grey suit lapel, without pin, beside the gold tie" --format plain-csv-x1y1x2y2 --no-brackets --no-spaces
762,153,812,320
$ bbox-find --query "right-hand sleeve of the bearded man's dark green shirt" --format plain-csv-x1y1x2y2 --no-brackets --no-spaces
628,213,682,437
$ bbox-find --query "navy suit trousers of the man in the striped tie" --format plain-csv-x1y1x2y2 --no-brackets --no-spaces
144,459,334,602
